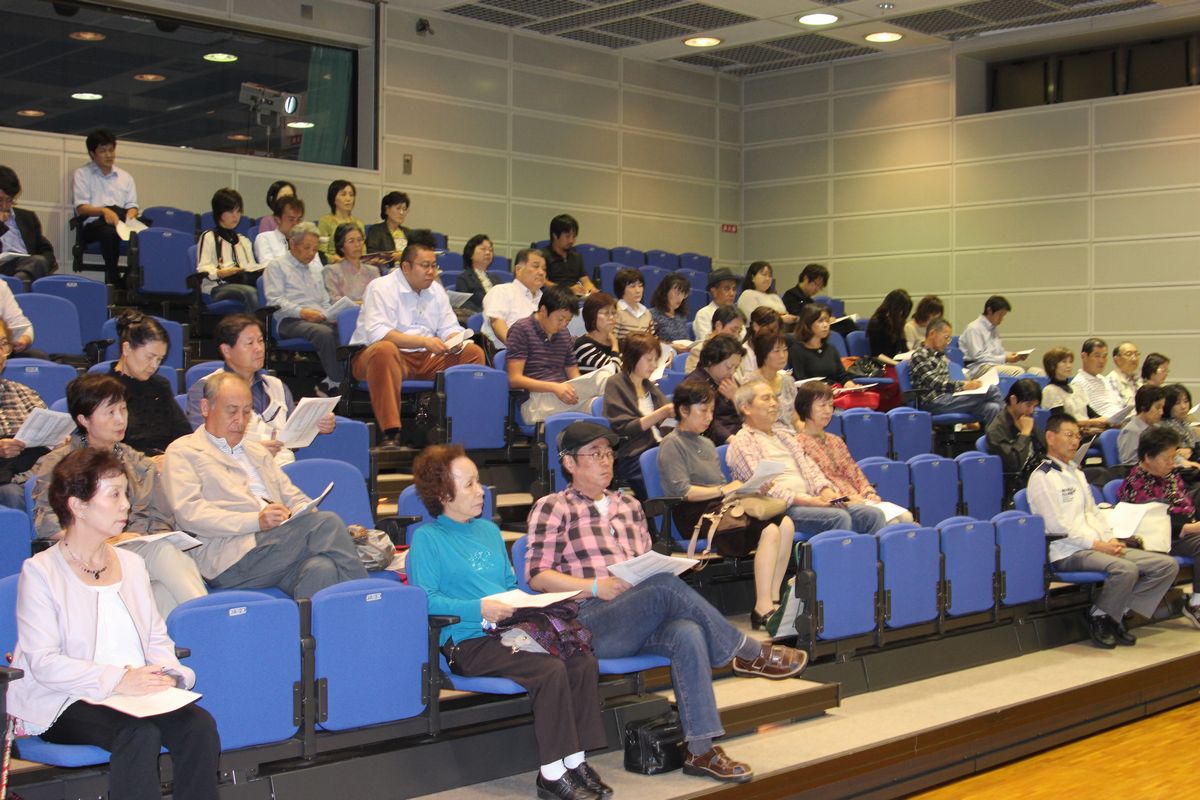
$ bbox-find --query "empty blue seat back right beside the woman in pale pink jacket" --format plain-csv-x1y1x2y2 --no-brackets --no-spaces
167,591,300,751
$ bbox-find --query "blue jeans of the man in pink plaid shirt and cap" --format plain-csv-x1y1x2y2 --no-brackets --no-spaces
580,573,743,741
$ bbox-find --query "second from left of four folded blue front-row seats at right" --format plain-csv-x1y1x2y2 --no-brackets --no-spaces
878,525,942,627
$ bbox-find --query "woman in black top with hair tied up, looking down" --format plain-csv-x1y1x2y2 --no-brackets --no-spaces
108,308,192,456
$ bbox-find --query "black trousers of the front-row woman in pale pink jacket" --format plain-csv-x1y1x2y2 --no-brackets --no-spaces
42,700,221,800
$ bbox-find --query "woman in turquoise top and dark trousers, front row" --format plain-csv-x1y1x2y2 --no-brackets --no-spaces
408,445,612,800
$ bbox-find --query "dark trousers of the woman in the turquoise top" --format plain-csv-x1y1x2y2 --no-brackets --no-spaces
443,636,608,764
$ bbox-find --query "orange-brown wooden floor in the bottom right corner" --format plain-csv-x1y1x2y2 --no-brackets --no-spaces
912,702,1200,800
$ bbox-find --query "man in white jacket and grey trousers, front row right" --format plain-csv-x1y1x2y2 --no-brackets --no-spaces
1028,414,1180,649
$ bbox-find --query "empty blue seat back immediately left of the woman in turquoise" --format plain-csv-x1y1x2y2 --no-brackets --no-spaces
312,578,428,730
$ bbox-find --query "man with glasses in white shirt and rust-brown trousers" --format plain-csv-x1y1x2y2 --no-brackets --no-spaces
350,230,484,447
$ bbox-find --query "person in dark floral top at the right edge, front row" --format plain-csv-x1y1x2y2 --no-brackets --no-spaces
1117,426,1200,627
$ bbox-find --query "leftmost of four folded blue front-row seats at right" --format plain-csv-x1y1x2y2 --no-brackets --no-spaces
804,530,878,640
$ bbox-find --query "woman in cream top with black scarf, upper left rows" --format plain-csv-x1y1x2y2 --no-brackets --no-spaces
196,188,263,314
